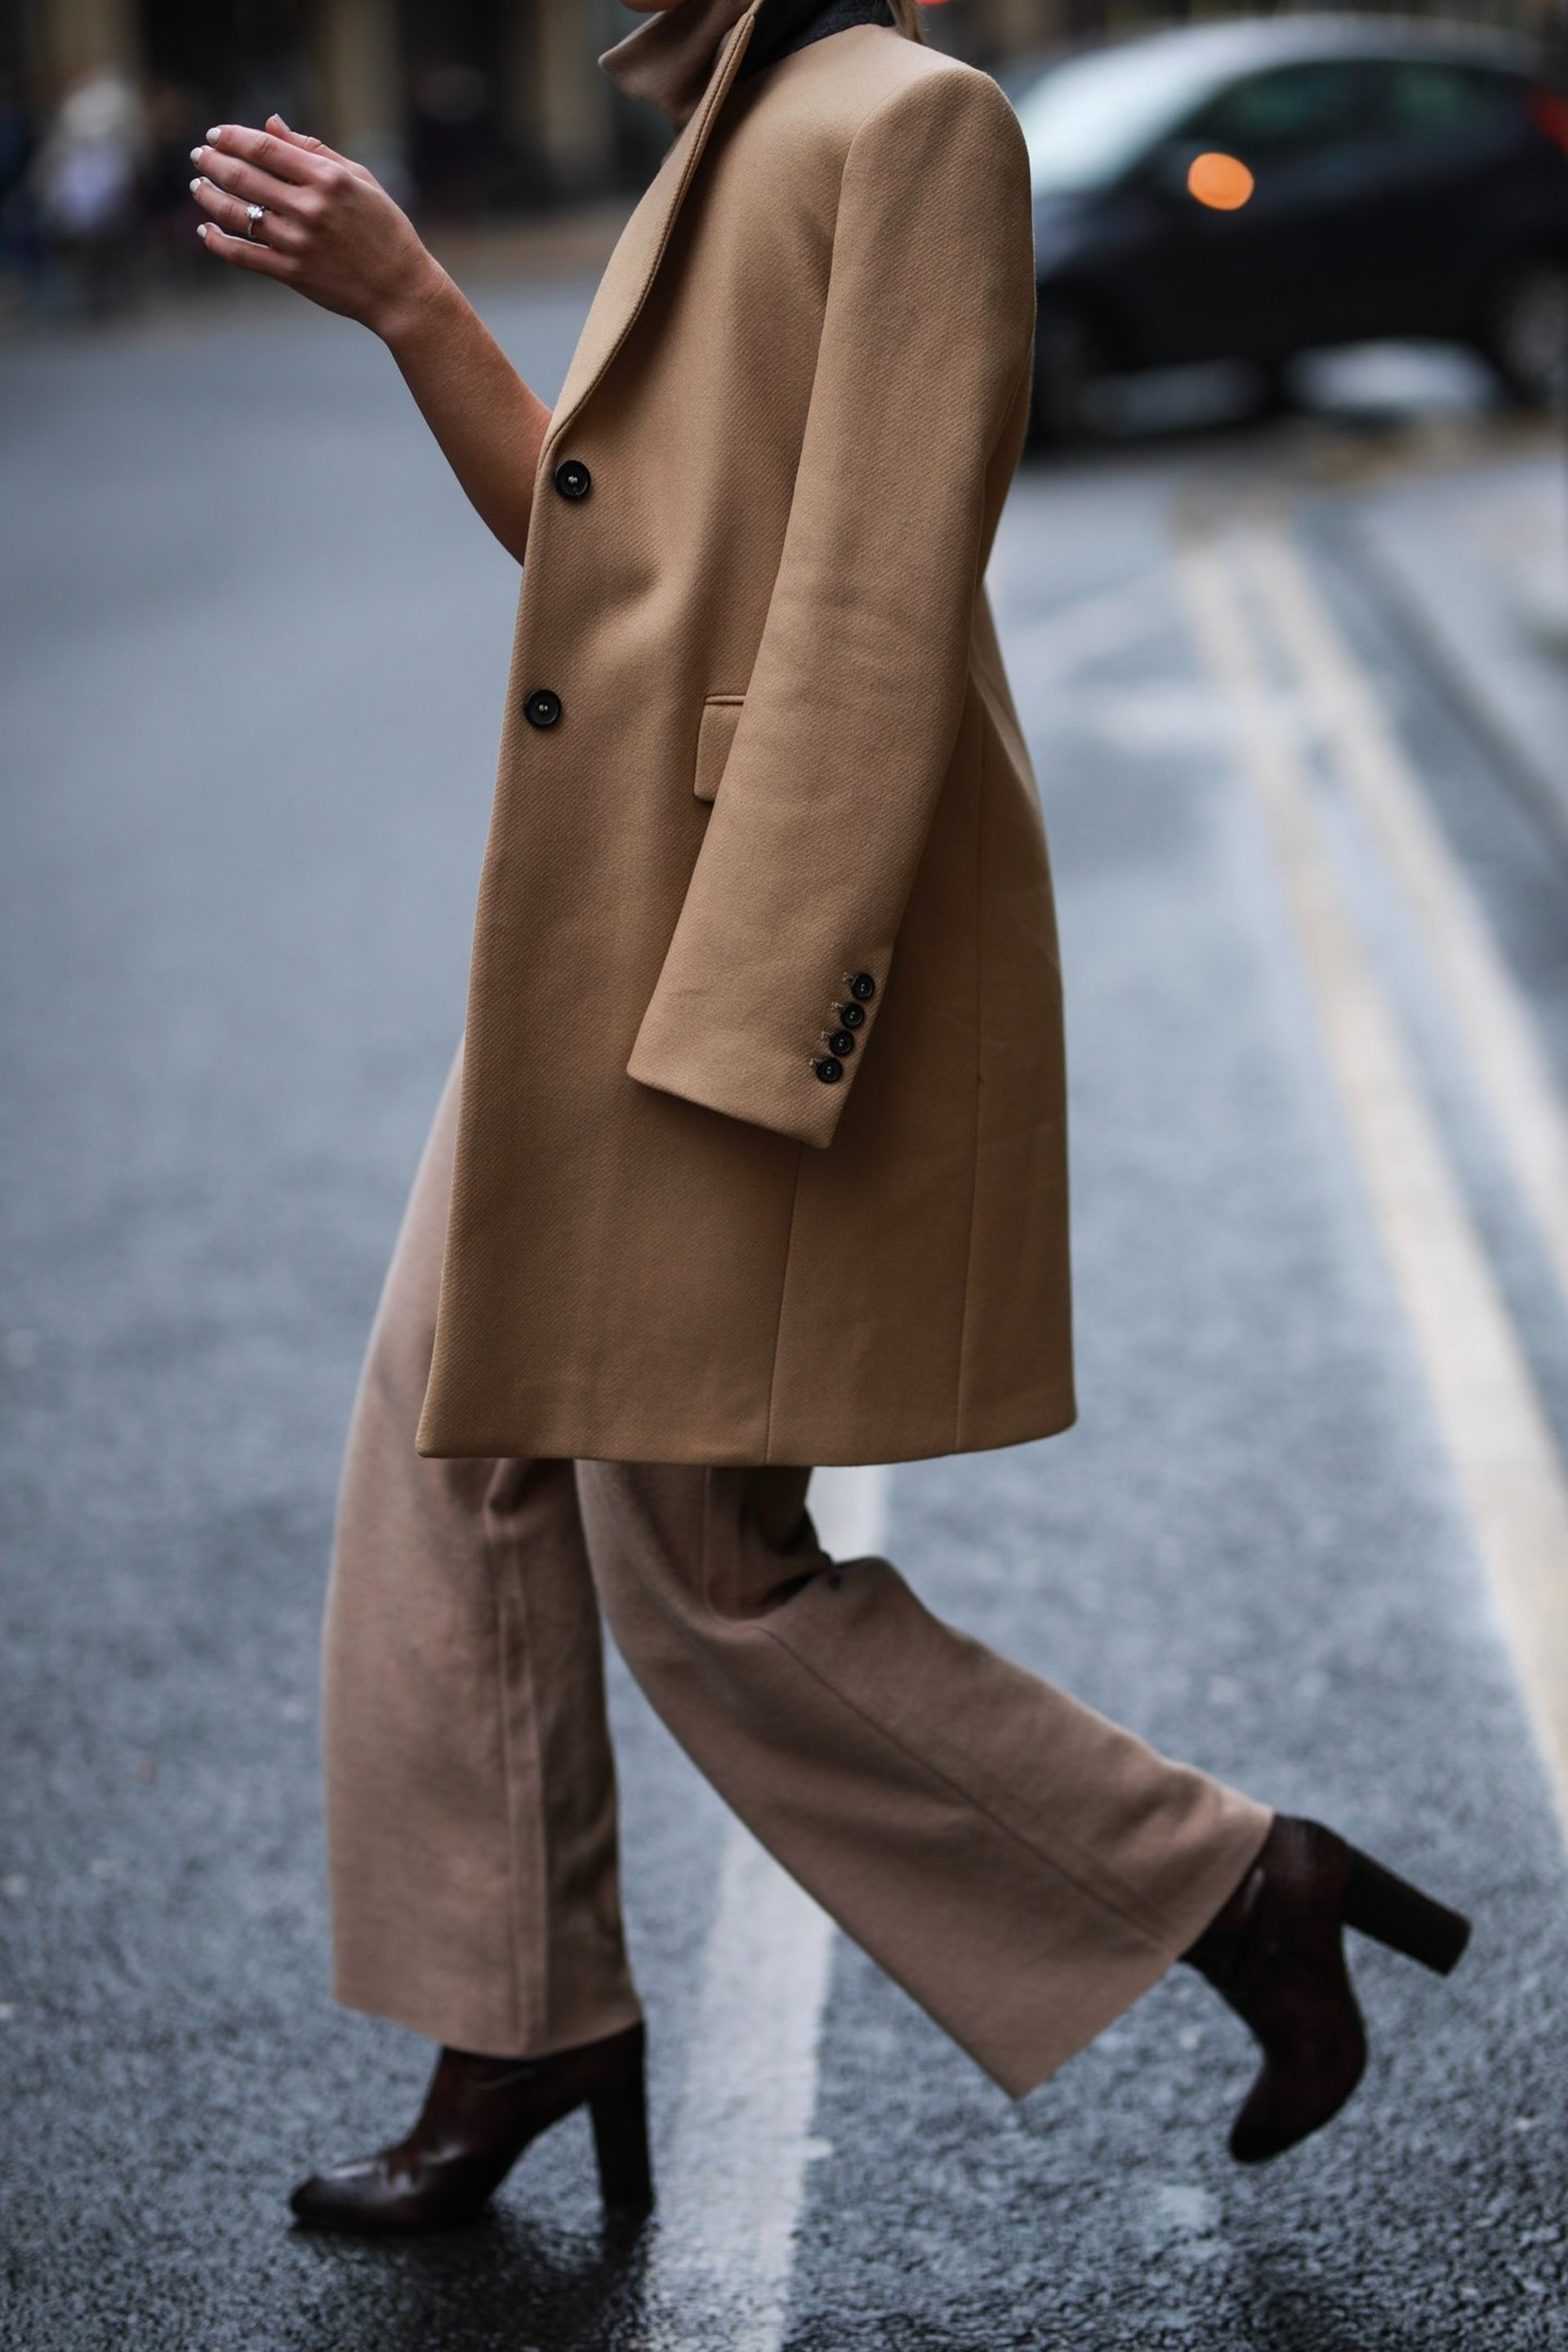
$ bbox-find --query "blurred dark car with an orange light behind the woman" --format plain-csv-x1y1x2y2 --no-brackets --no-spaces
1009,16,1568,440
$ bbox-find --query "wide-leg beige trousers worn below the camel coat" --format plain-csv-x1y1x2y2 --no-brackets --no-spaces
324,1072,1272,2096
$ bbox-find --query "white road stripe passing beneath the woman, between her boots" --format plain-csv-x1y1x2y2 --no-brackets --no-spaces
647,1470,891,2352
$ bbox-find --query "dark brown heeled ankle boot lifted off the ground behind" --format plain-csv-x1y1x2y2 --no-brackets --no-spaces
1183,1813,1469,2164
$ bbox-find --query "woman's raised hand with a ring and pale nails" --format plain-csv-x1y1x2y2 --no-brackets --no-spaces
190,115,447,341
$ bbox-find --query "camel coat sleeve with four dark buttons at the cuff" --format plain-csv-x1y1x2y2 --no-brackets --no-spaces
628,69,1035,1146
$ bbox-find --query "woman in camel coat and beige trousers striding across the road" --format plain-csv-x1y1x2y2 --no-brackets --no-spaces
193,0,1467,2230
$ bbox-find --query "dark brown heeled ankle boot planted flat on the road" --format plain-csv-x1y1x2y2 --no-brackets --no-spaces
289,2025,653,2232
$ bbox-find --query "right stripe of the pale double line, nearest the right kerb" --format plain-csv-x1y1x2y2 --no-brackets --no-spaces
1246,529,1568,1301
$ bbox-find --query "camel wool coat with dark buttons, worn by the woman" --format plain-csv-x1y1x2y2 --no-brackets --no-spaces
418,5,1075,1465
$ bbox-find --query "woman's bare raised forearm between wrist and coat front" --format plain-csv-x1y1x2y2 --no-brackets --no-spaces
374,264,550,562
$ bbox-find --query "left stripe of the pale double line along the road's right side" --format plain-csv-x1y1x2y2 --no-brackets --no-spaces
1178,524,1568,1825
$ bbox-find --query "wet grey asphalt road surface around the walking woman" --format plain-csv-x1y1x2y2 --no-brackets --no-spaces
0,284,1568,2352
